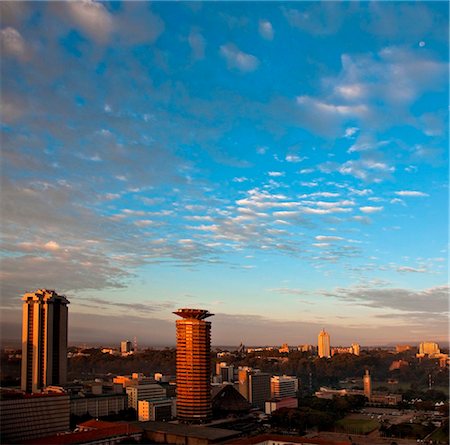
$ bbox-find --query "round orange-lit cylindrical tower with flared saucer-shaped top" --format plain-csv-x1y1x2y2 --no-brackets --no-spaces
174,309,213,423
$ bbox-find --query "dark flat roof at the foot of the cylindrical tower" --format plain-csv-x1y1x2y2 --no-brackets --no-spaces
138,421,241,441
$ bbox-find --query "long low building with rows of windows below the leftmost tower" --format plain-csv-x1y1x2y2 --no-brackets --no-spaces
0,390,70,444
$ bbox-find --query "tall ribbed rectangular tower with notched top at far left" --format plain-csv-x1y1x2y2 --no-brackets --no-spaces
21,289,69,393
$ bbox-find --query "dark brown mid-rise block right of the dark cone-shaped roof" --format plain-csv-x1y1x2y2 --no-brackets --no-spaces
238,367,271,409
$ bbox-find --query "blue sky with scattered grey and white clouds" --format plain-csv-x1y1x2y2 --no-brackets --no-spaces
0,0,449,346
